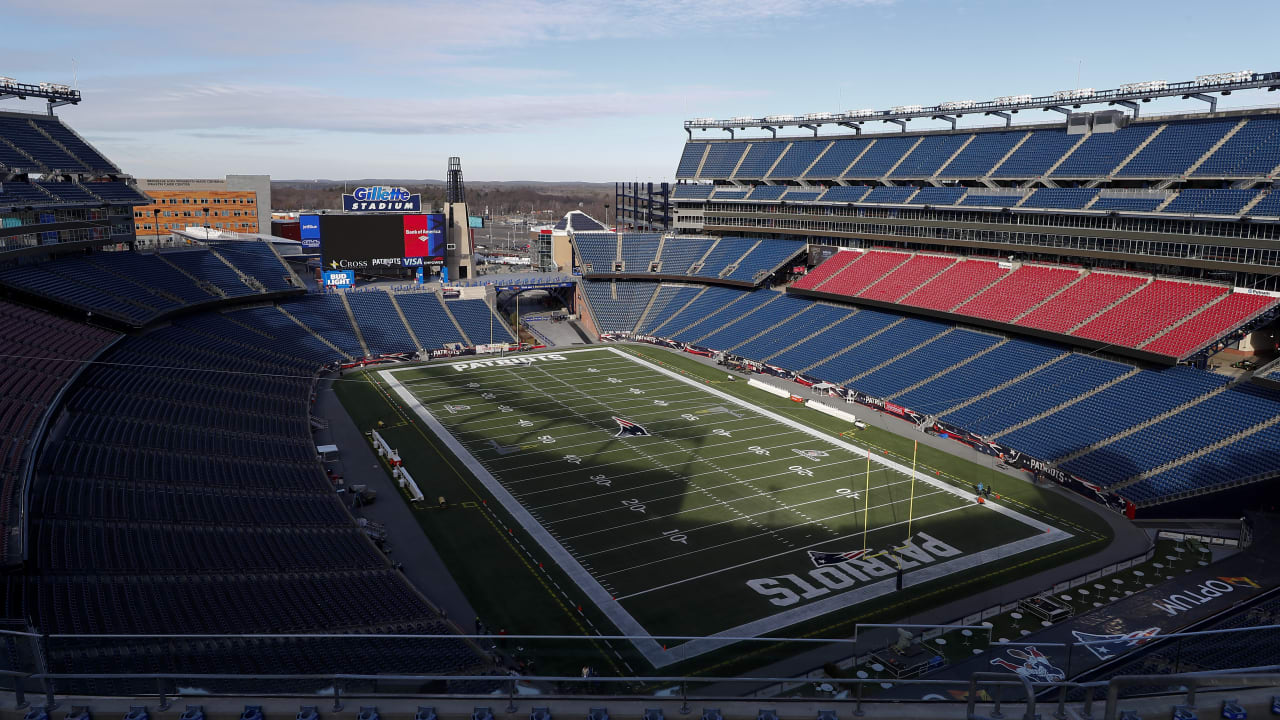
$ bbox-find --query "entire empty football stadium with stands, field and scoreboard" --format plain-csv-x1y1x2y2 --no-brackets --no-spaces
0,63,1280,720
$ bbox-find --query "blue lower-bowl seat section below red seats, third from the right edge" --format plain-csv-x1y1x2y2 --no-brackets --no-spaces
1001,368,1228,458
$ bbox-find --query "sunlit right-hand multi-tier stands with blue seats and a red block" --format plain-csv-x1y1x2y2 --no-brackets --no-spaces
573,74,1280,515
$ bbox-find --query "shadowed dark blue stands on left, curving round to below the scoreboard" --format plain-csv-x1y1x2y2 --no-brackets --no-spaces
0,99,529,693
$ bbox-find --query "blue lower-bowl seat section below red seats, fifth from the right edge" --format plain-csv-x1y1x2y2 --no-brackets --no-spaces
892,333,1065,414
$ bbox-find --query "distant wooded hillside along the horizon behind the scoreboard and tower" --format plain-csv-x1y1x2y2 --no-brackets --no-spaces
271,178,613,220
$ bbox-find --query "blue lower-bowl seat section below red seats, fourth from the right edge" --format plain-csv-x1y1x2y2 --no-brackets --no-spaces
942,354,1133,436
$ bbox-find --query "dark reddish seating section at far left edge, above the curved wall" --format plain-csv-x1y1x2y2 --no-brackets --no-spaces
0,302,116,562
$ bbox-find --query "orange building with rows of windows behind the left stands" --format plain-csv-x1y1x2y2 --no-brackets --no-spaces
133,190,259,238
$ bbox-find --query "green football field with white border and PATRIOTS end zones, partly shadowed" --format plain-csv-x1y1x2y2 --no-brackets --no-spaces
378,347,1071,667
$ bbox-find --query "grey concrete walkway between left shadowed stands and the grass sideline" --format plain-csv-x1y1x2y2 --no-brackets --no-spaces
315,379,476,625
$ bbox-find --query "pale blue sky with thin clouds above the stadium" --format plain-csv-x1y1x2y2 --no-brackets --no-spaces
0,0,1280,182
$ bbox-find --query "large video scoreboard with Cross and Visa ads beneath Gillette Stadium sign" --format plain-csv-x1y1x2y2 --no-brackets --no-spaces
300,213,445,274
